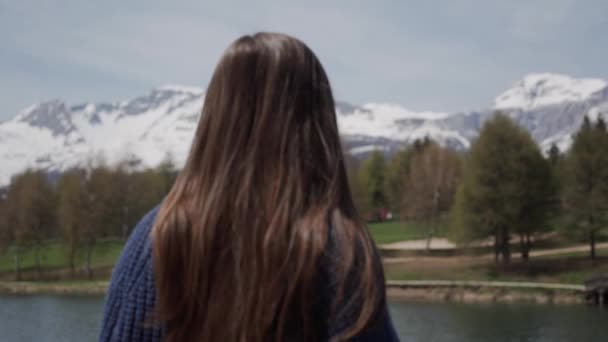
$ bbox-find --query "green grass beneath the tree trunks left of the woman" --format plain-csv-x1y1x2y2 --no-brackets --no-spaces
0,239,124,273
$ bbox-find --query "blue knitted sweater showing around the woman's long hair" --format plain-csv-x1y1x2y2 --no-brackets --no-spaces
99,207,398,342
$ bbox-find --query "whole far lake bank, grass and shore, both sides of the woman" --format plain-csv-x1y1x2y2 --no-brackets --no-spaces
0,232,608,303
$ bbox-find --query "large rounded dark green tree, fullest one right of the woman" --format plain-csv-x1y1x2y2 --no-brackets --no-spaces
451,113,554,263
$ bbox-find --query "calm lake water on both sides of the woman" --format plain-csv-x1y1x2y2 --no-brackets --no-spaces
0,296,608,342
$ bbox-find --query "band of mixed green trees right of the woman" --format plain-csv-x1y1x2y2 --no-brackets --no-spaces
347,113,608,264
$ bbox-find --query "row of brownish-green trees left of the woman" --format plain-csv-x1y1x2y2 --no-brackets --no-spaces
0,159,177,280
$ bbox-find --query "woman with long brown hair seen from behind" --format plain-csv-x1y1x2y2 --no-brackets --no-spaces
100,33,397,342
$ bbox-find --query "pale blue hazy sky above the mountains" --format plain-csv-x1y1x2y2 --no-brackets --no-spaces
0,0,608,120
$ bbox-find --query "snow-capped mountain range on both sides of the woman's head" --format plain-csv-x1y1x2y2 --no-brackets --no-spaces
0,74,608,187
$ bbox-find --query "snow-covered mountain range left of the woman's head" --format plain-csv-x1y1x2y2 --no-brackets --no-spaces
0,86,204,186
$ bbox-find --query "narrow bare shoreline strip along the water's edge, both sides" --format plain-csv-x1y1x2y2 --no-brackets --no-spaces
0,280,585,304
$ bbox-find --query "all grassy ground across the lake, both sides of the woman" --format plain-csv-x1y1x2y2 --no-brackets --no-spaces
0,221,608,284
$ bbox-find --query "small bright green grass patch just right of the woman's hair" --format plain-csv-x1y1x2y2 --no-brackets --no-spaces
367,220,444,244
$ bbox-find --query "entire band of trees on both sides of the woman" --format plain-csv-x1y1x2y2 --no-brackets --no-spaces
0,113,608,279
